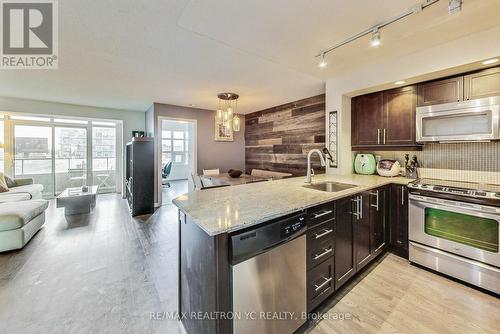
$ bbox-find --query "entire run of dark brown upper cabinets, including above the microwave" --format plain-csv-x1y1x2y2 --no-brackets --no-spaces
351,66,500,151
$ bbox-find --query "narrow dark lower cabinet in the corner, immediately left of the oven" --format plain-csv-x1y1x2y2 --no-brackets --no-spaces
390,184,408,258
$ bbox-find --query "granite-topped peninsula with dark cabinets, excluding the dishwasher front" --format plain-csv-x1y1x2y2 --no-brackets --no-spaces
173,175,411,333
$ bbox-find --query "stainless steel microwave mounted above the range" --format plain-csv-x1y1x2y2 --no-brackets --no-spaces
416,96,500,143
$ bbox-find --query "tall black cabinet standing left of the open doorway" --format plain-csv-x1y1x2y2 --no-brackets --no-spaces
126,138,154,216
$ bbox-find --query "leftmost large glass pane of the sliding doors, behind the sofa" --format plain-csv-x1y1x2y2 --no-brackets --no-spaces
14,125,54,195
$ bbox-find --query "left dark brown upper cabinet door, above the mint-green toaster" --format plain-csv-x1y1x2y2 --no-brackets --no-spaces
351,92,384,146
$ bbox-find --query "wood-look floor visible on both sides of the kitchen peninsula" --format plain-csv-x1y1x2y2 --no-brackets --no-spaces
0,194,500,334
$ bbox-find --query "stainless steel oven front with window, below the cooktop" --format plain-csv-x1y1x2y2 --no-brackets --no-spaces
409,194,500,293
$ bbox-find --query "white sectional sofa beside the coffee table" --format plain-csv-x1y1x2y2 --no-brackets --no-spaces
0,179,49,252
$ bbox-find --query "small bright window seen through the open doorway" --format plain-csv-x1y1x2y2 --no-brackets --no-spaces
161,130,189,165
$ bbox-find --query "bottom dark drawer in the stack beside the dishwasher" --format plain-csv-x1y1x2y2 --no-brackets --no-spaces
307,258,335,312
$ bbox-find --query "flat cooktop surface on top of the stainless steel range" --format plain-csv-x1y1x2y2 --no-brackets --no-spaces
408,179,500,202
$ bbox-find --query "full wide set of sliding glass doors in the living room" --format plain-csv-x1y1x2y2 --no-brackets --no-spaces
5,115,121,197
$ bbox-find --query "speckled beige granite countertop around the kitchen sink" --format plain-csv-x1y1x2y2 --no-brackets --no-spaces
173,174,412,236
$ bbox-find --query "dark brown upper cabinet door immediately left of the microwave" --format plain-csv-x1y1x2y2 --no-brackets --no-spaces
382,86,417,146
